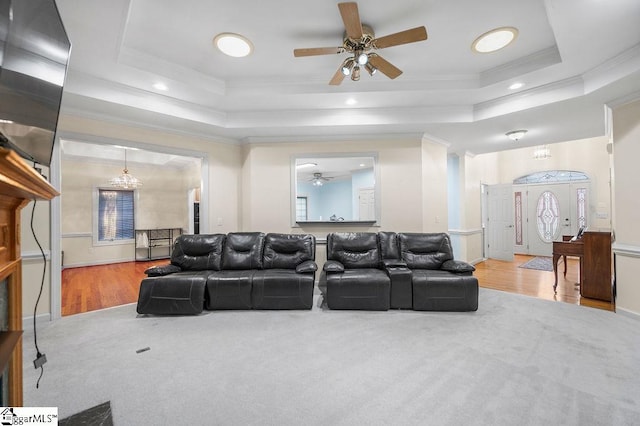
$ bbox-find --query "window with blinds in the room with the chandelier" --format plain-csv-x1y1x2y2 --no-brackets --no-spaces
97,189,135,241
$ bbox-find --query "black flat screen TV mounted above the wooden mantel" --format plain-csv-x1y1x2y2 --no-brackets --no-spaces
0,0,71,166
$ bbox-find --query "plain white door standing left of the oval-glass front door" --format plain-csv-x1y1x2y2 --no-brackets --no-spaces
487,184,515,262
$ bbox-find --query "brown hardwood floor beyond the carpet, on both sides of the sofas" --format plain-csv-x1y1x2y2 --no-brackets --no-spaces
62,255,615,316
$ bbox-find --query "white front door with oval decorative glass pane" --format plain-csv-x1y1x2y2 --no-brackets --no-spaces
527,183,575,256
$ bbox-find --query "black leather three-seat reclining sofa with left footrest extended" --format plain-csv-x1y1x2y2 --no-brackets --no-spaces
137,232,318,315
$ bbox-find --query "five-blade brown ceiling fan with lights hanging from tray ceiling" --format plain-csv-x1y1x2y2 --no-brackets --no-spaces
293,2,427,86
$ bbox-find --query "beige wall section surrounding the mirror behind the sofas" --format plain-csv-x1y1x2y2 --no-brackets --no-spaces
242,140,428,238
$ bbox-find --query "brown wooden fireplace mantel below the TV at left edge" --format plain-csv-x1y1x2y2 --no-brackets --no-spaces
0,148,60,407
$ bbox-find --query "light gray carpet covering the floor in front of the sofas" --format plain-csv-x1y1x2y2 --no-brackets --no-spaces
24,289,640,425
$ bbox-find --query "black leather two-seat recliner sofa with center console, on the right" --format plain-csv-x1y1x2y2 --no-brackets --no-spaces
319,232,478,311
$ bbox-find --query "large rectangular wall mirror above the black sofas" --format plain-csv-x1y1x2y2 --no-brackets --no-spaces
291,153,380,225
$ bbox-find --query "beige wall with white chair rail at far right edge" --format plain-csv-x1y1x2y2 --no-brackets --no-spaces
613,100,640,315
